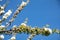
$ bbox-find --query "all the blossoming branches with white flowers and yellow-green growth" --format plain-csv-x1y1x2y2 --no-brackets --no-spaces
0,0,60,40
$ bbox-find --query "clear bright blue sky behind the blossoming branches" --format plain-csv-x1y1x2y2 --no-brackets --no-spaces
0,0,60,40
